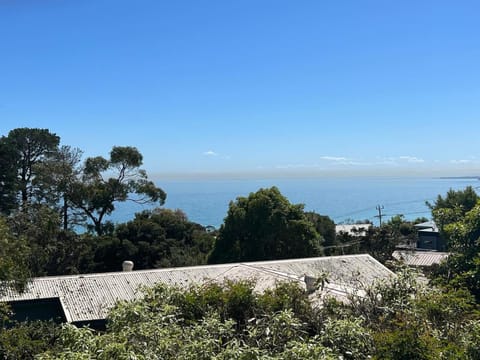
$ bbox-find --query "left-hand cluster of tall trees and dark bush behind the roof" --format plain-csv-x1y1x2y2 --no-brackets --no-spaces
0,128,215,278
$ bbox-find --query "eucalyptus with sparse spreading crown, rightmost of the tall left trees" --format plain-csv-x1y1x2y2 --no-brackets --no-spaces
69,146,166,235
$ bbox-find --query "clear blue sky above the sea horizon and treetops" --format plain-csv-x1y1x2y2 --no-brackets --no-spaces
0,0,480,177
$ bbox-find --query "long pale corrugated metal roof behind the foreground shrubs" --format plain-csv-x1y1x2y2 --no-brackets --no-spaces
0,255,393,322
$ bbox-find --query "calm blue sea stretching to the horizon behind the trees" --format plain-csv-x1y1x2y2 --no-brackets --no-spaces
111,177,480,227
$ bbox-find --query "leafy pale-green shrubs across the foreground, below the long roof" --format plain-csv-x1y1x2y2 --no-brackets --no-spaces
0,271,480,360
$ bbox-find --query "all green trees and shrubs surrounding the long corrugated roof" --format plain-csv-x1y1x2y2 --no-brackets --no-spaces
0,128,480,359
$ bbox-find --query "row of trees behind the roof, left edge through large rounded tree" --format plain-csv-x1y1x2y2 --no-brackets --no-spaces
0,128,342,280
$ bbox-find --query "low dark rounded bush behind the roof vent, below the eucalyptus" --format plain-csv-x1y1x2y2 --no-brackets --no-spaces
89,209,214,272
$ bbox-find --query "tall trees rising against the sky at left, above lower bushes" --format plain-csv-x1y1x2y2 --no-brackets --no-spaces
0,128,166,235
